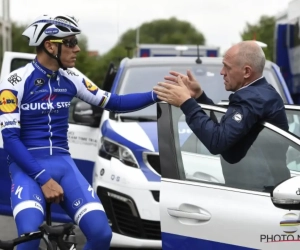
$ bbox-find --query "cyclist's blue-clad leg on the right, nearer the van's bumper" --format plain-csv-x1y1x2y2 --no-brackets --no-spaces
56,156,112,250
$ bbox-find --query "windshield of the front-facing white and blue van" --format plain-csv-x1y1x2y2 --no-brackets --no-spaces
117,64,280,120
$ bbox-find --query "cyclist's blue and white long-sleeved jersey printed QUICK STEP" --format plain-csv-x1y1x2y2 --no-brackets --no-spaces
0,59,157,185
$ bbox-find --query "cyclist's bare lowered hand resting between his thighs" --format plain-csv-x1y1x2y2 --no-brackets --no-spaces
42,179,64,203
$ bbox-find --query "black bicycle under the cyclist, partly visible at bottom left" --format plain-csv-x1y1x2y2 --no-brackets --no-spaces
0,203,77,250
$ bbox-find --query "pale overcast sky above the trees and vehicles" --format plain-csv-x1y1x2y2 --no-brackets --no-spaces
10,0,291,53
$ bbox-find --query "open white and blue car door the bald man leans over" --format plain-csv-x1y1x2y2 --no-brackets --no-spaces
157,103,300,250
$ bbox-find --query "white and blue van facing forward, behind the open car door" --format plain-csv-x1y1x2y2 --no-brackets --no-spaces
93,57,292,249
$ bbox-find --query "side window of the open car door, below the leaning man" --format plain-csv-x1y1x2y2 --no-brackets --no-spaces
173,110,300,192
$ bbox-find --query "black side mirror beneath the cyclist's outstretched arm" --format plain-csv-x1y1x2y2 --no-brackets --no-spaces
73,101,103,127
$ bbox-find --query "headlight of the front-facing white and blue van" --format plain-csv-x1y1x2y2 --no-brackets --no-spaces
99,137,138,168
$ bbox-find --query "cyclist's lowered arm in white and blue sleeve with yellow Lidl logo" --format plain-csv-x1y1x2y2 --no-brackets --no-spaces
0,72,51,185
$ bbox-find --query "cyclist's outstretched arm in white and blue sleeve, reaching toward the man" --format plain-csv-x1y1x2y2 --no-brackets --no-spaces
68,76,159,113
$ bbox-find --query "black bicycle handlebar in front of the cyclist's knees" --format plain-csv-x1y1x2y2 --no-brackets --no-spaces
0,223,74,250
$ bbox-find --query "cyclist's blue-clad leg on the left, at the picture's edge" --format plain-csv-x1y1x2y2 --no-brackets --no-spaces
10,163,45,250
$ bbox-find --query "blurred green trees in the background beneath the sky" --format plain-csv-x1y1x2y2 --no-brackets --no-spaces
12,16,275,87
